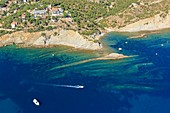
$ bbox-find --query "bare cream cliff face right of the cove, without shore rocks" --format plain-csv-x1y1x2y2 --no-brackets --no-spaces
115,11,170,32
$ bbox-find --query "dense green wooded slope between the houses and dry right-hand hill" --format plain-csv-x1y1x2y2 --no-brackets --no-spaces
35,0,137,35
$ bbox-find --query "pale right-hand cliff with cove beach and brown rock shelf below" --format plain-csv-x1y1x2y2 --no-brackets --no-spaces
105,11,170,38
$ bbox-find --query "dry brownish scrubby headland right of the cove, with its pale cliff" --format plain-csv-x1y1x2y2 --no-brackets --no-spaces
105,0,170,31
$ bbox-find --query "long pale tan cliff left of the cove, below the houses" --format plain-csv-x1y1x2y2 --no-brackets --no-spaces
0,30,102,50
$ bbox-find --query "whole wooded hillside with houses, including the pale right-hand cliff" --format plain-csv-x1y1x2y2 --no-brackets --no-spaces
0,0,170,49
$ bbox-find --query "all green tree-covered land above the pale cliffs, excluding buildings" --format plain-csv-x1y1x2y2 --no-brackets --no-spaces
0,0,170,35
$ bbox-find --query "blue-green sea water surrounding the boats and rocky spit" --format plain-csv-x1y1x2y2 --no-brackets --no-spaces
0,33,170,113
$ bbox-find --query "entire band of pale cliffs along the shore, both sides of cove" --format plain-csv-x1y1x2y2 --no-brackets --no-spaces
0,11,170,50
